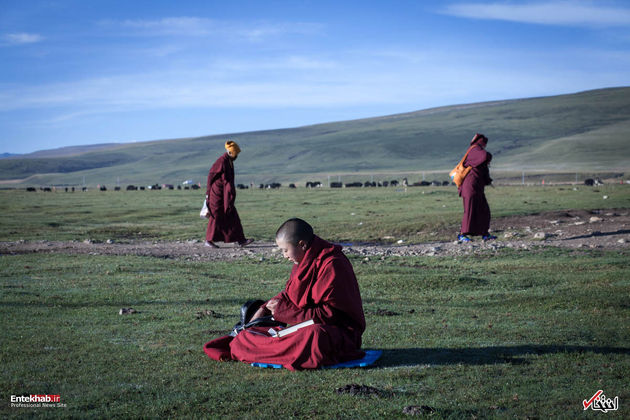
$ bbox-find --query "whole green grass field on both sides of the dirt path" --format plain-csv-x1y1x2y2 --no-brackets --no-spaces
0,185,630,419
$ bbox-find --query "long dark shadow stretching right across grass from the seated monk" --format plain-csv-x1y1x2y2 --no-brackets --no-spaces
376,345,630,367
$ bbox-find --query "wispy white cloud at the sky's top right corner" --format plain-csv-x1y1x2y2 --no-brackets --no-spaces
441,1,630,26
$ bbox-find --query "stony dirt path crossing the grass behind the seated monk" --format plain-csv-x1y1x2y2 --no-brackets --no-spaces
0,209,630,261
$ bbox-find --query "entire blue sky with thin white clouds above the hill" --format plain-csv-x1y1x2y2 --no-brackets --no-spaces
0,0,630,153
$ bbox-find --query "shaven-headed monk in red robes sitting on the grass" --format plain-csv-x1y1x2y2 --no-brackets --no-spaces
204,219,365,370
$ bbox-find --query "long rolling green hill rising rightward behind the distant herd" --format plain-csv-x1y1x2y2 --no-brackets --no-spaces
0,87,630,186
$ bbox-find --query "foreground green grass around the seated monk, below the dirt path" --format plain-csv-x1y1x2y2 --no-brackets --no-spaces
0,250,630,419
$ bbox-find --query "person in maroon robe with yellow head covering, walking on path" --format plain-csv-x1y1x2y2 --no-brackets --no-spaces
205,140,254,248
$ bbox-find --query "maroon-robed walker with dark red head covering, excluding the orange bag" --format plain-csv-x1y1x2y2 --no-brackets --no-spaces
457,133,497,242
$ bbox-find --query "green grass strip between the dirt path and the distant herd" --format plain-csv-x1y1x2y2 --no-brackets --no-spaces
0,185,630,242
